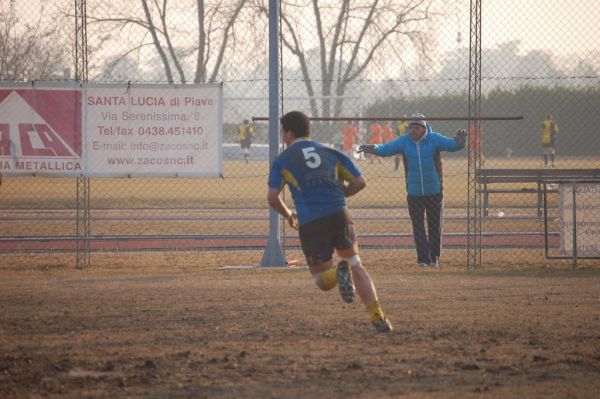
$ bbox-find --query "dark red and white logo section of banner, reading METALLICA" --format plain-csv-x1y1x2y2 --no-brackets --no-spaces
0,84,85,176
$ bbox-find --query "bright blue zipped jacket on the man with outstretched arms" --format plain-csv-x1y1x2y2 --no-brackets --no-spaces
375,123,464,196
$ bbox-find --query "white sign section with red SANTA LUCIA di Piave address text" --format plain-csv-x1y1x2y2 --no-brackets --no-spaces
84,84,223,176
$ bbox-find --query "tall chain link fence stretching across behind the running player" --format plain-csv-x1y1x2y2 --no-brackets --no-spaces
0,0,600,267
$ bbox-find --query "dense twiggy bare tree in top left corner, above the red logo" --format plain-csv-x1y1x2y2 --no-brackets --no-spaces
0,0,69,81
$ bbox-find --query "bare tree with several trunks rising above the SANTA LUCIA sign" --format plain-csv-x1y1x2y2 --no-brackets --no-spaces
88,0,248,83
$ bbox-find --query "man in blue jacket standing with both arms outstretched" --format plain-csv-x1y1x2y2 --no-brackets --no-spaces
358,114,467,267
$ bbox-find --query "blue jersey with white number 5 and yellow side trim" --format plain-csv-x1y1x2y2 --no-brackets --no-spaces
269,139,360,225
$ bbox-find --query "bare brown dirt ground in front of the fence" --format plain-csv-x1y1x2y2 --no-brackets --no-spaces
0,253,600,399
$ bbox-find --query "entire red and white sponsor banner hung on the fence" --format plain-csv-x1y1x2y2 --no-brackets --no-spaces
0,84,223,177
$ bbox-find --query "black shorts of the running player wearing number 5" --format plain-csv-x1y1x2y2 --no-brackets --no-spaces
299,210,356,265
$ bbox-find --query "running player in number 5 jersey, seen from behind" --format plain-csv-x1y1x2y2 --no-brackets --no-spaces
267,111,392,332
